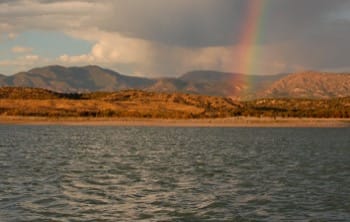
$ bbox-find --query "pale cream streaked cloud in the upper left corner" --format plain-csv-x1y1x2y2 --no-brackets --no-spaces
0,0,104,32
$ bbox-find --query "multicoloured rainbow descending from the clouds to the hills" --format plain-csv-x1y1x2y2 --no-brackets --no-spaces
234,0,268,96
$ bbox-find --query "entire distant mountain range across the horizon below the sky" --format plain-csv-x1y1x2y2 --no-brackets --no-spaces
0,65,350,99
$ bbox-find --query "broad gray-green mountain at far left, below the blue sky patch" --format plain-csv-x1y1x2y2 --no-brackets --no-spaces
4,66,155,92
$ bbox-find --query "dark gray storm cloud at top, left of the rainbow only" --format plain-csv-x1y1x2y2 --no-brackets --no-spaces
94,0,244,47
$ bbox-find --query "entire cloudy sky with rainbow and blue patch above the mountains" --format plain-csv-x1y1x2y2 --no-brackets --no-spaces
0,0,350,77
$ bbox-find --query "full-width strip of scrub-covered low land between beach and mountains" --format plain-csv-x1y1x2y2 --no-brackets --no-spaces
0,87,350,118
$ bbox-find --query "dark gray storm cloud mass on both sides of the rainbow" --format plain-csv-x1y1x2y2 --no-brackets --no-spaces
97,0,350,70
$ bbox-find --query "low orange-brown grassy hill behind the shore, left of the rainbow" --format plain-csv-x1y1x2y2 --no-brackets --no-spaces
0,87,239,118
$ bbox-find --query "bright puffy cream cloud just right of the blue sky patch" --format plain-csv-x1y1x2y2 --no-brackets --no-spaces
57,29,222,76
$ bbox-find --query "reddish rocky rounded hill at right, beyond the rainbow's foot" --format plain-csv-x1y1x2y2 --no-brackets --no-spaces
260,72,350,98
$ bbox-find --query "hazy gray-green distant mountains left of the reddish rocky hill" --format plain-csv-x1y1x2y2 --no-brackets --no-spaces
0,66,282,96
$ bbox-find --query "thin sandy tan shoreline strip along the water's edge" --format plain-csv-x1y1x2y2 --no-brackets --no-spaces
0,116,350,128
